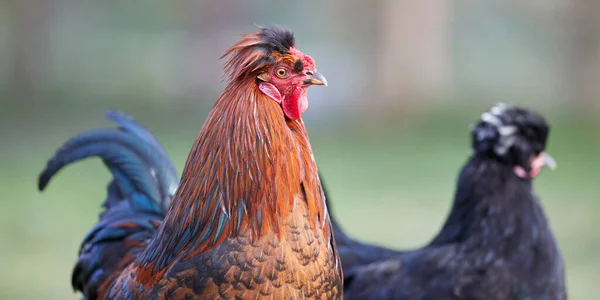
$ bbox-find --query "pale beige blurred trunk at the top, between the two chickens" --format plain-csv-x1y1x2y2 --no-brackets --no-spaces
377,0,453,113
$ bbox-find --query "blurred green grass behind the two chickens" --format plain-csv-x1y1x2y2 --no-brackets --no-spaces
0,107,600,299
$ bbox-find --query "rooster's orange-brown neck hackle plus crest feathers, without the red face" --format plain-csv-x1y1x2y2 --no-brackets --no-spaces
137,28,330,282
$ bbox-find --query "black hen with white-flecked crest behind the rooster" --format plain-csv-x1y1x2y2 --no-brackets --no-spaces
326,104,567,300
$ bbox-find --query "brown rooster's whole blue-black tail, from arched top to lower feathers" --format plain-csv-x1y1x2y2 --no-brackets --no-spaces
38,111,179,300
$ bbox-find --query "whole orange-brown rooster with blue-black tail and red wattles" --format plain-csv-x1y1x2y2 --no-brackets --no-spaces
39,27,342,299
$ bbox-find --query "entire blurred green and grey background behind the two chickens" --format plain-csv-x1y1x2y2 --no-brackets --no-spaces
0,0,600,299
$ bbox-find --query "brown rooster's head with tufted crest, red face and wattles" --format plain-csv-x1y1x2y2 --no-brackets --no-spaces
223,26,327,120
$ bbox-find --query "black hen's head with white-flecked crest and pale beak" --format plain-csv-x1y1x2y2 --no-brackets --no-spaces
471,103,556,179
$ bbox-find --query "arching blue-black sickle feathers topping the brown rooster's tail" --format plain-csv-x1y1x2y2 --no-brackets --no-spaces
38,111,179,212
